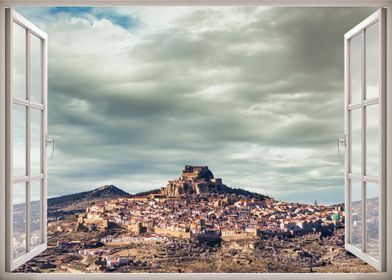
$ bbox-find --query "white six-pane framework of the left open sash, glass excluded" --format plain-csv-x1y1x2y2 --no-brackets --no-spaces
6,9,47,271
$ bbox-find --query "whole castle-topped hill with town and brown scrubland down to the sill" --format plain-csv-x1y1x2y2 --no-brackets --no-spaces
15,165,373,272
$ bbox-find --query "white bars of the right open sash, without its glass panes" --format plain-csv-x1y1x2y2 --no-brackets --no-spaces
344,9,386,271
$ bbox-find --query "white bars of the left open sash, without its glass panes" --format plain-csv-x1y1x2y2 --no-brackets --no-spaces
6,9,47,271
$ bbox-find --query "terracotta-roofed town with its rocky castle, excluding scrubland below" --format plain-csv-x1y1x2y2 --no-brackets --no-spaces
77,166,344,240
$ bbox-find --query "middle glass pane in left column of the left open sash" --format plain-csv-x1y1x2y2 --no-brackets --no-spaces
12,105,26,176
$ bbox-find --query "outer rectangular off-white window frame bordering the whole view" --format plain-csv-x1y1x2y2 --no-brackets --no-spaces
0,0,392,280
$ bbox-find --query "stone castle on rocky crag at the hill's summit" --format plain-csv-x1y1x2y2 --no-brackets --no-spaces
161,165,228,197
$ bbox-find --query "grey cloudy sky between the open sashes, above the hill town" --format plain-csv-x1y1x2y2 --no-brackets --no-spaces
18,7,373,203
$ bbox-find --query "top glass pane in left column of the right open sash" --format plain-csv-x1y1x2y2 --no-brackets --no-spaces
350,33,362,104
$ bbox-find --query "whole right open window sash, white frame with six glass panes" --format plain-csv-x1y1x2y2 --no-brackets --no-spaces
345,9,386,271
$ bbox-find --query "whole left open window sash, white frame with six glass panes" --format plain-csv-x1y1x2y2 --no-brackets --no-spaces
6,9,47,270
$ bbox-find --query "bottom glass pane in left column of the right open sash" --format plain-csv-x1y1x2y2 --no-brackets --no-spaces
350,181,362,248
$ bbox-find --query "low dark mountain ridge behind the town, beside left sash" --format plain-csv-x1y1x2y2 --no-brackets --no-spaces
48,185,131,212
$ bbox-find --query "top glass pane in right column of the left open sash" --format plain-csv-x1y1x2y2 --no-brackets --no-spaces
30,34,42,103
